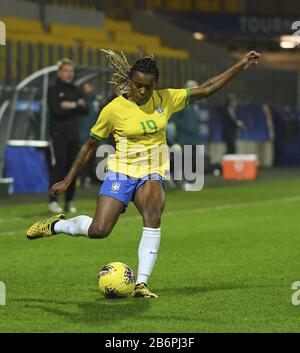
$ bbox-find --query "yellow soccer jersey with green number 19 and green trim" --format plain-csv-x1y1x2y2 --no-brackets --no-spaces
90,89,190,178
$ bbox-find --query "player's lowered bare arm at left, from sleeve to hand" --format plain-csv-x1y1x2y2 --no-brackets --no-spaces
50,138,100,196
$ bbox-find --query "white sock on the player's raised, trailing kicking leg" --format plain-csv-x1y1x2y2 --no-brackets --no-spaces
54,216,93,236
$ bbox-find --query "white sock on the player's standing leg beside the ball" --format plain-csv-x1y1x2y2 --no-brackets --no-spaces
136,227,160,283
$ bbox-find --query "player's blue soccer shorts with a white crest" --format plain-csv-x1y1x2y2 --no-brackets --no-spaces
99,170,163,207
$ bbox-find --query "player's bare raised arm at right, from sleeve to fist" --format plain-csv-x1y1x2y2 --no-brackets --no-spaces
190,50,261,102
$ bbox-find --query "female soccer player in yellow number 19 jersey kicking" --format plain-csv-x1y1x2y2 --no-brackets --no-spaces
27,50,260,298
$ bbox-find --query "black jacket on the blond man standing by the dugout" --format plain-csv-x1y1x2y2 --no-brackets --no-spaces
48,78,88,133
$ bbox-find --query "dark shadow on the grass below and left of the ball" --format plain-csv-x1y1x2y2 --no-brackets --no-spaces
12,291,151,327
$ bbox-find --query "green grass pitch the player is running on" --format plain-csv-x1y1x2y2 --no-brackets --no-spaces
0,172,300,332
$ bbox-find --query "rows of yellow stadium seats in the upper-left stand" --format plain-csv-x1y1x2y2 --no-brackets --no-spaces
1,13,189,82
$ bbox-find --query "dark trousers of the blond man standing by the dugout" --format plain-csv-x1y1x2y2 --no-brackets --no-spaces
49,131,80,202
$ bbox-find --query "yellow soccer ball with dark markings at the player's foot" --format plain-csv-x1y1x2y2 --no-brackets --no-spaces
98,262,135,298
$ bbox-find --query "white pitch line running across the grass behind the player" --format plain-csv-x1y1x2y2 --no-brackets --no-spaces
0,195,300,236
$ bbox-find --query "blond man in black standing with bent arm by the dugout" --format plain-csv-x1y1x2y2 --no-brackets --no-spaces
48,59,87,213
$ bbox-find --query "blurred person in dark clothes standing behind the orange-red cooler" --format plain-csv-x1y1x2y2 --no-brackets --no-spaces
220,94,244,154
